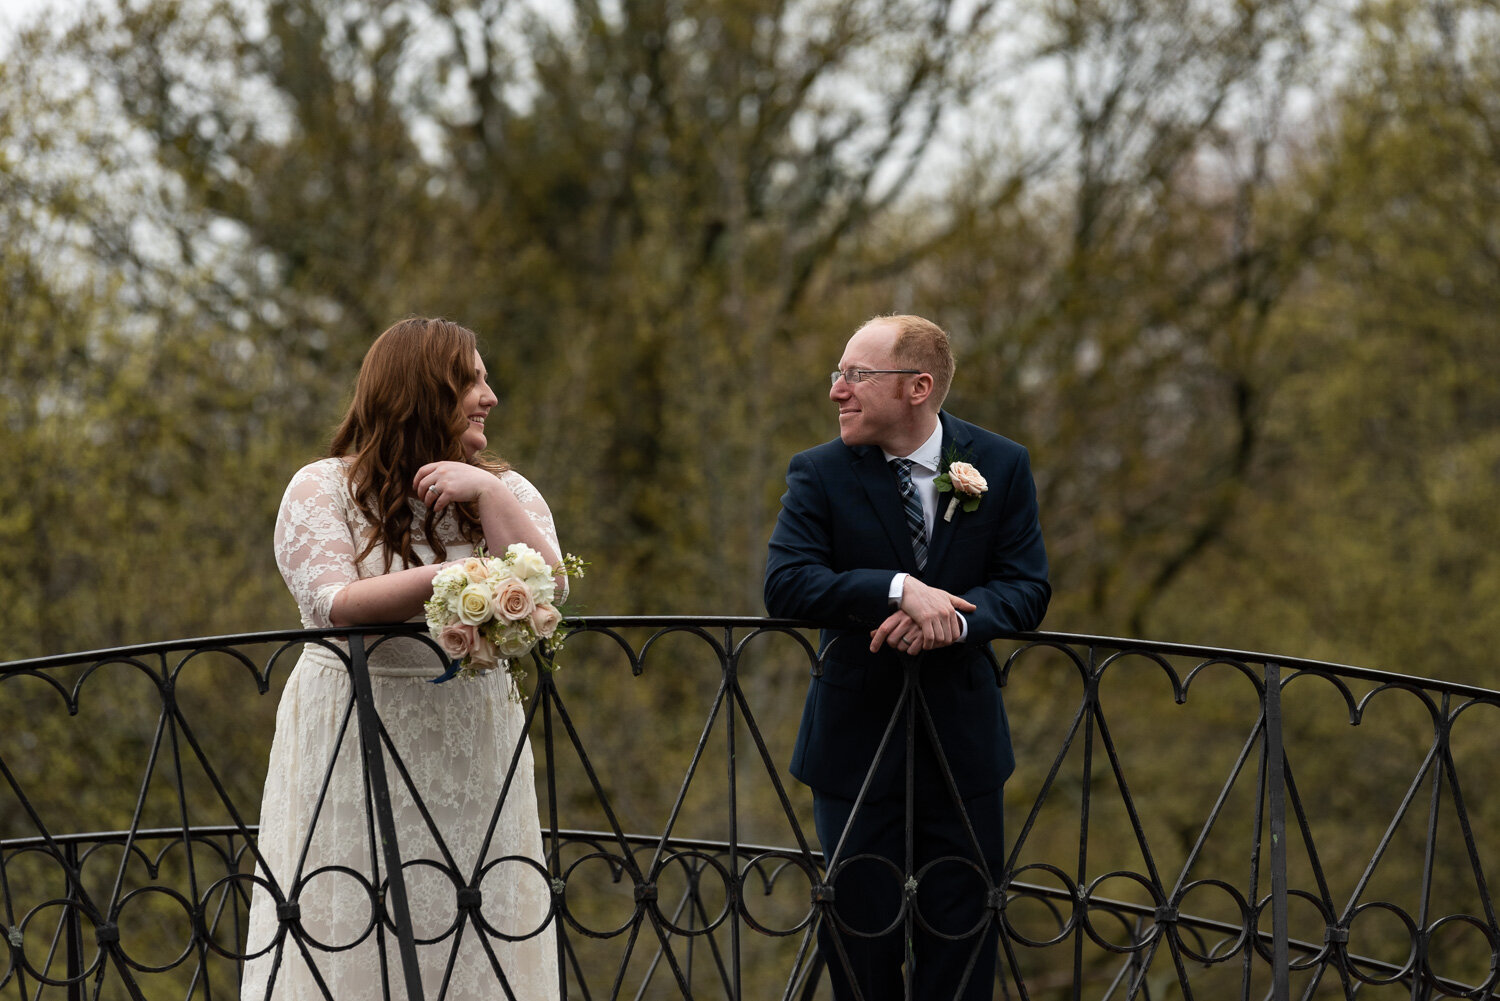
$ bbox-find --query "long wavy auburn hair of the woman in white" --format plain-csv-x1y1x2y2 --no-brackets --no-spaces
329,317,510,573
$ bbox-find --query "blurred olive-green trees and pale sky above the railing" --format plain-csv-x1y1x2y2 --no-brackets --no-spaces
0,0,1500,683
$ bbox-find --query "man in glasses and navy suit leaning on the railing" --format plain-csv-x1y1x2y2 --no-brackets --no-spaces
765,315,1052,1001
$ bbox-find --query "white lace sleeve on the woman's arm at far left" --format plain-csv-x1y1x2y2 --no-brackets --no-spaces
276,459,359,629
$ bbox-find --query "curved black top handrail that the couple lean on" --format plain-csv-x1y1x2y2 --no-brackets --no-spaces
0,615,1500,701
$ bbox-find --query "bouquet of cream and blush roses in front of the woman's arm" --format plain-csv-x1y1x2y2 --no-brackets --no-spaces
423,542,588,690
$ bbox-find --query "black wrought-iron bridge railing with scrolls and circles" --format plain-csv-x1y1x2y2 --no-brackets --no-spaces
0,617,1500,1001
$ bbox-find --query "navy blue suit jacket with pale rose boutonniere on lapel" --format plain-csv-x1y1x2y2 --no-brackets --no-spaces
765,413,1052,798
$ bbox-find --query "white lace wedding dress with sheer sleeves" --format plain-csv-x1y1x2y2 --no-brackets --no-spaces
240,459,560,1001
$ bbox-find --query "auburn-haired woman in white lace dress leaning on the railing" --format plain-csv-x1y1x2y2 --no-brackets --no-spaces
240,318,567,1001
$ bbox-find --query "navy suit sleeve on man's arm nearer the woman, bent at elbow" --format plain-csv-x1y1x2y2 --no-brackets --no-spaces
765,453,896,629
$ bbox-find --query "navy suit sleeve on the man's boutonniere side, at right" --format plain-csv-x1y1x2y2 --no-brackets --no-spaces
963,449,1052,642
